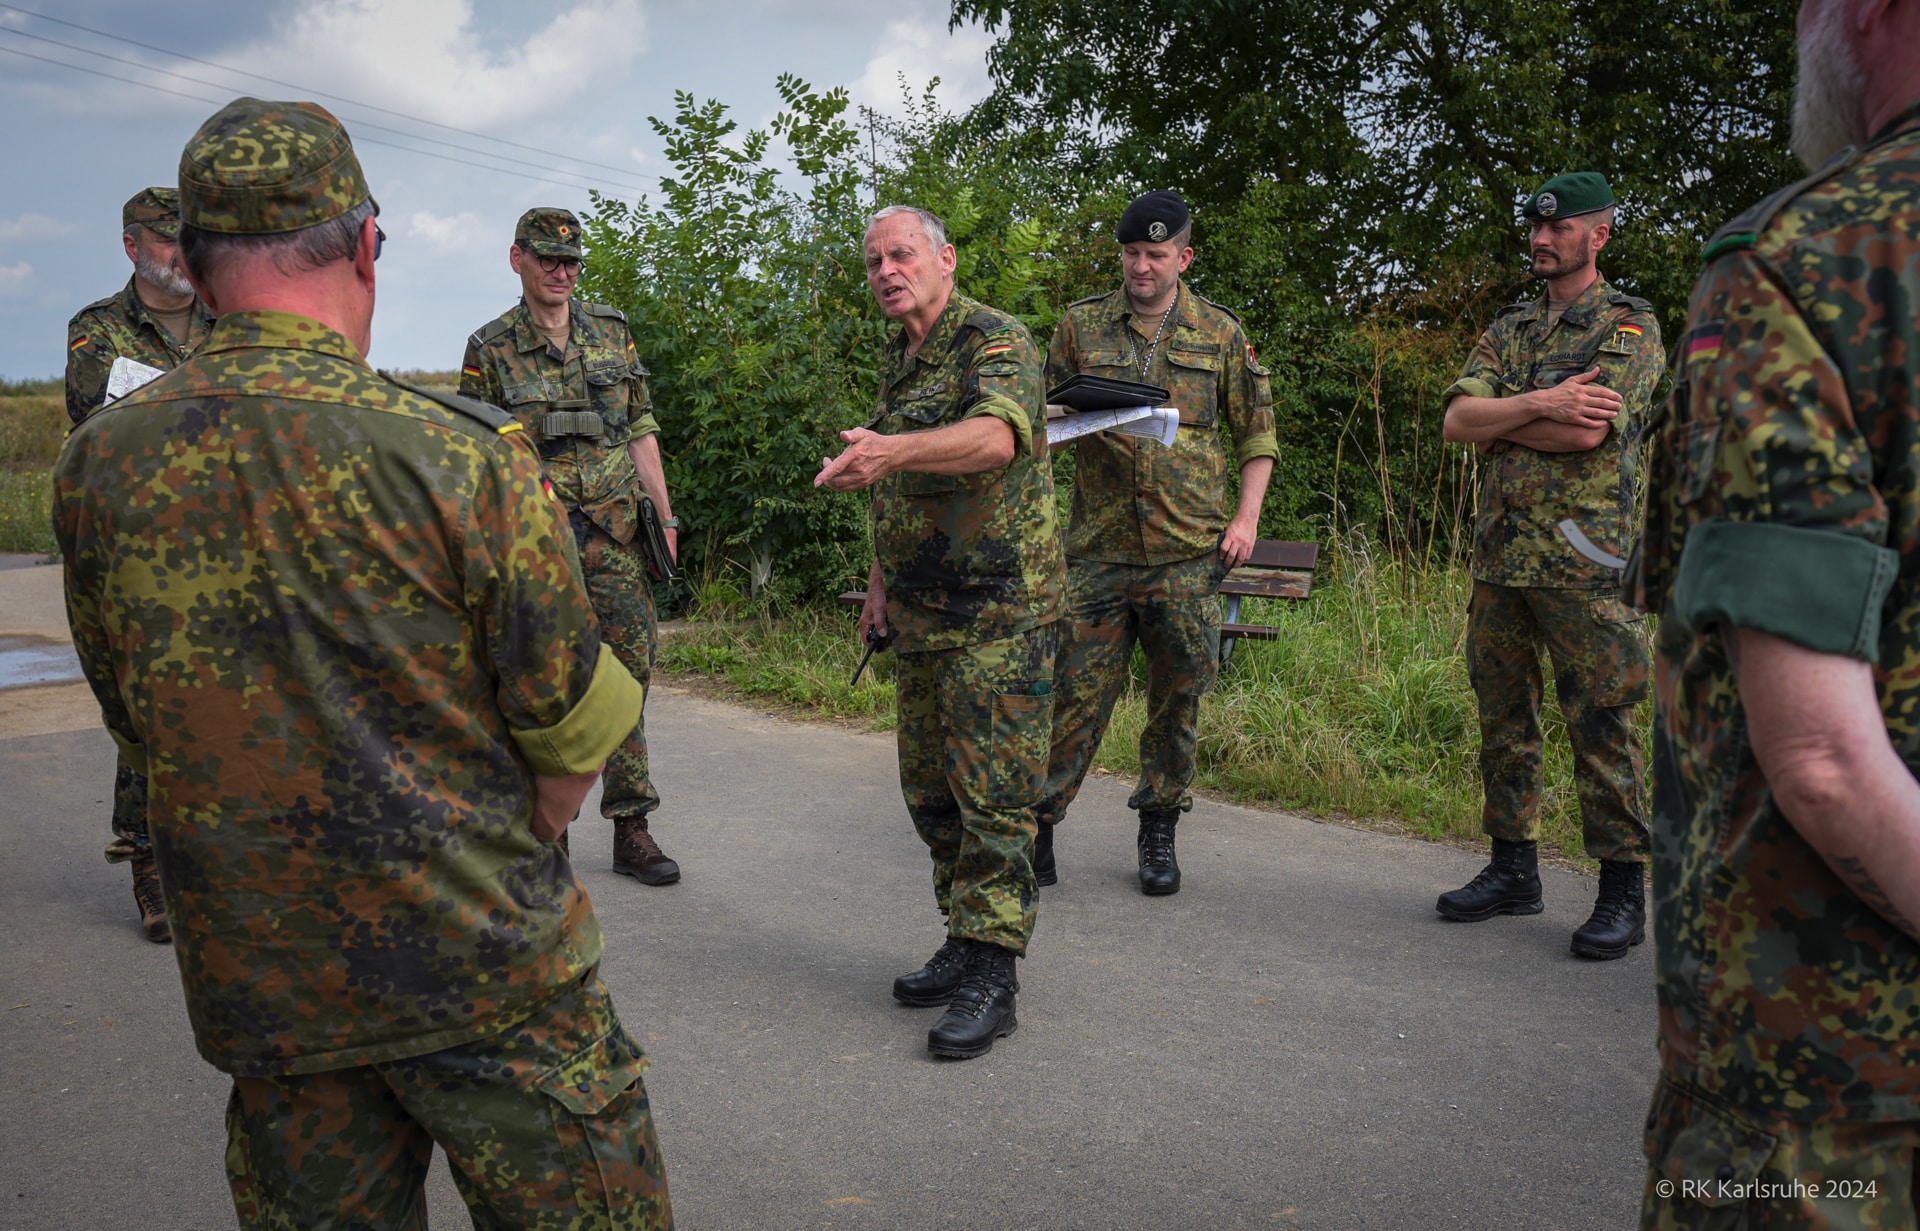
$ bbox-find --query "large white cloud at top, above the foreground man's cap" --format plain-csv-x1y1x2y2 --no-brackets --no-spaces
223,0,647,128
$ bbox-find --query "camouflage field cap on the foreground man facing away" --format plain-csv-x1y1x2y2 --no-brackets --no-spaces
180,98,380,234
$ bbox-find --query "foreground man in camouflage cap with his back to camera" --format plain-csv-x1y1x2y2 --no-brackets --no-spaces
54,98,672,1231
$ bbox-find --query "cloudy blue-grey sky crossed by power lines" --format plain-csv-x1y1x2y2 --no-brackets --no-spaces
0,0,991,378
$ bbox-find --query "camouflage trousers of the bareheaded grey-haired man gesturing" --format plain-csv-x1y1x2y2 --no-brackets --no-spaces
895,624,1058,954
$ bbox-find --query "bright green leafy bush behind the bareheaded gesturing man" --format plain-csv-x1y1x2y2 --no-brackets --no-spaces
582,75,1123,601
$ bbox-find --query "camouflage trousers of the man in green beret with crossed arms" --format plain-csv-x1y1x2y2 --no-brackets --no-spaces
1467,582,1651,862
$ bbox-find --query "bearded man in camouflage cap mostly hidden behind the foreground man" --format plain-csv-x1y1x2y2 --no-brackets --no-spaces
67,188,213,945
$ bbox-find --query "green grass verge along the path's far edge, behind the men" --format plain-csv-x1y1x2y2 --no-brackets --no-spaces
660,534,1620,857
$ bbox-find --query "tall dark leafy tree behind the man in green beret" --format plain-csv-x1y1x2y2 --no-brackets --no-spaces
952,0,1795,551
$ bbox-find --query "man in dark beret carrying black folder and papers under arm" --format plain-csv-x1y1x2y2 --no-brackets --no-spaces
1033,190,1279,893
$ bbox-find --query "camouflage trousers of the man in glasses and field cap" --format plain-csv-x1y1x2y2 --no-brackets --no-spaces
570,513,660,818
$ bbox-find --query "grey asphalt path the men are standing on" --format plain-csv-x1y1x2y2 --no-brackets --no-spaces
0,567,1657,1231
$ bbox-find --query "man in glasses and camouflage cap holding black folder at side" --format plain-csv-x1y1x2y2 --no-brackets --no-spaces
461,207,680,885
